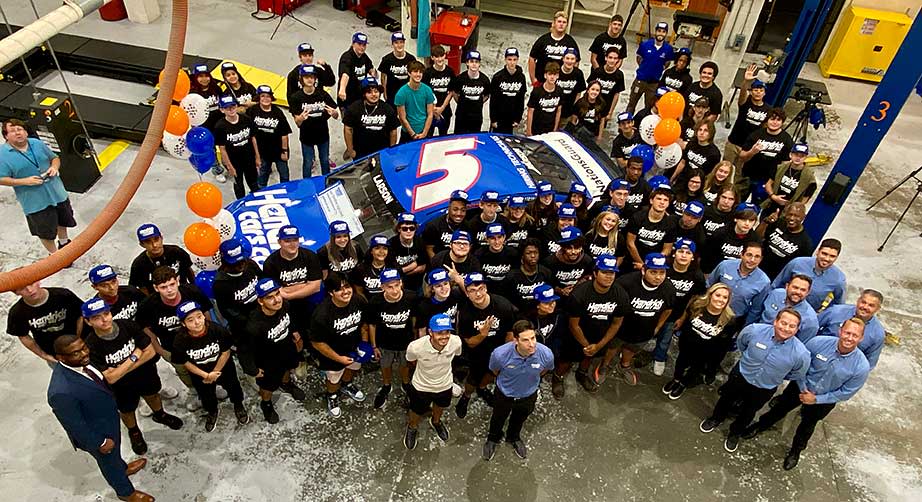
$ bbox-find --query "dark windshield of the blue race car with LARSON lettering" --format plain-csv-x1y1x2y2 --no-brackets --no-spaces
327,154,404,238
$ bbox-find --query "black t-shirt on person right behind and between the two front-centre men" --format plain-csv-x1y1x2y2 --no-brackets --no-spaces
458,293,519,363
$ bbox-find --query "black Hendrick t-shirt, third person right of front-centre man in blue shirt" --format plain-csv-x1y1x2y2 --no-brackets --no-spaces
615,271,675,343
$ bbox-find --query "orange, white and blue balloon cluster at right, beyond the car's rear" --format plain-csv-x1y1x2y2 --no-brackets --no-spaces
631,91,685,174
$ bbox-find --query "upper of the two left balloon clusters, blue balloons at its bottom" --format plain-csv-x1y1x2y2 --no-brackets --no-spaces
160,70,215,174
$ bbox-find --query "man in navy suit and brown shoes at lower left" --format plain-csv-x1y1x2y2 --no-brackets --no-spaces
48,335,154,502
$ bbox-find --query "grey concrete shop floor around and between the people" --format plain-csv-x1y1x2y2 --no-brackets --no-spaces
0,0,922,501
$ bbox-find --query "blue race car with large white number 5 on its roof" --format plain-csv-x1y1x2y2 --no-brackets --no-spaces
227,132,622,265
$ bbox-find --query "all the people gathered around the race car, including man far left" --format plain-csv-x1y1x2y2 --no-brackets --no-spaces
0,11,884,500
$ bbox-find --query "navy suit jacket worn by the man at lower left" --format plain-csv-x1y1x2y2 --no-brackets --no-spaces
48,363,121,453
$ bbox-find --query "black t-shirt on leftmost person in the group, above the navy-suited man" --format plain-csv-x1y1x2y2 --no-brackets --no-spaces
6,288,83,355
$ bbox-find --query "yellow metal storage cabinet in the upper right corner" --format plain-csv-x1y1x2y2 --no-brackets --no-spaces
819,6,912,82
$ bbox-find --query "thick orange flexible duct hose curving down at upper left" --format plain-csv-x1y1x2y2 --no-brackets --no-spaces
0,0,189,292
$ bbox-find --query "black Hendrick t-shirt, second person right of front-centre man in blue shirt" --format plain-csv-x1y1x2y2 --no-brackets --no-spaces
565,281,630,343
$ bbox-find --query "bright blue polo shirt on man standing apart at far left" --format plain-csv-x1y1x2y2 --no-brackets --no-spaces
0,138,67,214
